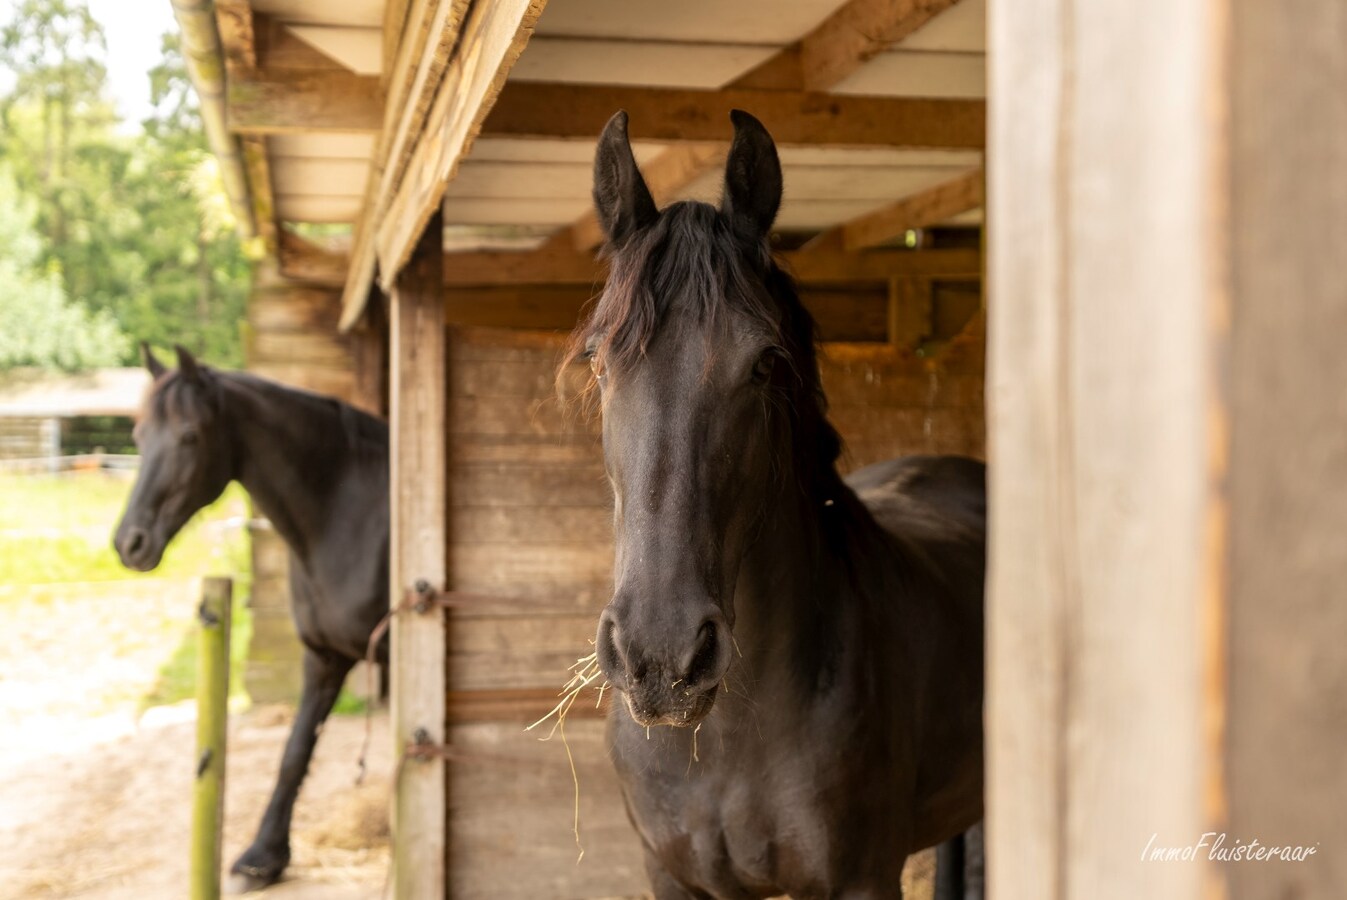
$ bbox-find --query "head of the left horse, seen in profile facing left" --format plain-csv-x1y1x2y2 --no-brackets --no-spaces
112,345,233,571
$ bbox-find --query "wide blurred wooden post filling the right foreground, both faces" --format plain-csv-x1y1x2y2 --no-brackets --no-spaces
987,0,1347,900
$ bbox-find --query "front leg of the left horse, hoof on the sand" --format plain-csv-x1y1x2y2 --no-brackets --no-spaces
229,648,356,891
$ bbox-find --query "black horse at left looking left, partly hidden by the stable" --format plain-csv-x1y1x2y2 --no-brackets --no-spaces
113,348,388,889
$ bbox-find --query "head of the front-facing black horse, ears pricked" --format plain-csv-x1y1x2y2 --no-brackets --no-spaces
572,110,836,725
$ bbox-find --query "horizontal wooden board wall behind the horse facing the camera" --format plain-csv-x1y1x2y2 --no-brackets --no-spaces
446,317,983,899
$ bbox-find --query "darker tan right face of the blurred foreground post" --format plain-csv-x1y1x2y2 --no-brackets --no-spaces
1226,0,1347,900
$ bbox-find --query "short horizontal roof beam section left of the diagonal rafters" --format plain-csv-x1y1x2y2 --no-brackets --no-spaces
226,69,384,135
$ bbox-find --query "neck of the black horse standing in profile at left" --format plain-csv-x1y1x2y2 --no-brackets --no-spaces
225,381,343,558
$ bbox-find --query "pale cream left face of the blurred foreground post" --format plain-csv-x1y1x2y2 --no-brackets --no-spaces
987,0,1224,900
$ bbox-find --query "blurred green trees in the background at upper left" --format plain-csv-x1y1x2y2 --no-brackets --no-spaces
0,0,248,368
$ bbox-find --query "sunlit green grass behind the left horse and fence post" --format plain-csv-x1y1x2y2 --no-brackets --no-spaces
0,472,252,709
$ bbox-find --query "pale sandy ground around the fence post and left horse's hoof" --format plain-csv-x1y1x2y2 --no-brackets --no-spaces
0,582,392,900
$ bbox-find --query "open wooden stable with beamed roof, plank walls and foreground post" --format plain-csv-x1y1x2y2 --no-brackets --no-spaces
175,0,1347,899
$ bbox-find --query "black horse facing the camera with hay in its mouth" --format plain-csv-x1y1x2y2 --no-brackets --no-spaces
571,110,986,900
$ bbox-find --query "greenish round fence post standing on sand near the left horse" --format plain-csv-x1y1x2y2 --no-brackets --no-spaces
191,578,233,900
